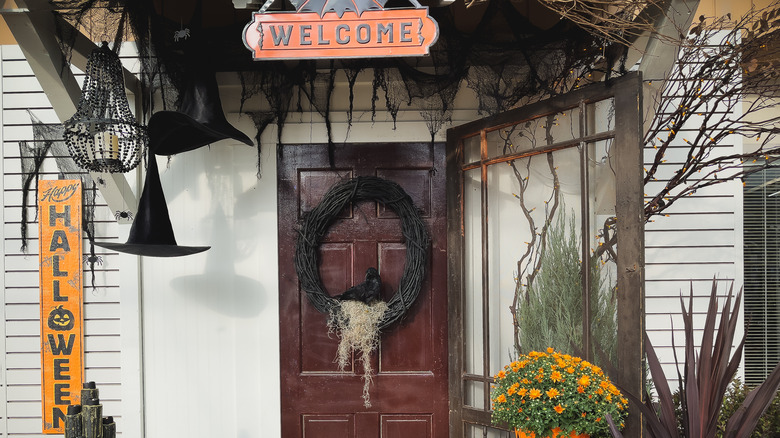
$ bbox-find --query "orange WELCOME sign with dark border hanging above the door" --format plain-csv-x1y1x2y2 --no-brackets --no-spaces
244,0,439,60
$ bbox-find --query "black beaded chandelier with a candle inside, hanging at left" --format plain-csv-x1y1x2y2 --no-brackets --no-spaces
63,42,149,173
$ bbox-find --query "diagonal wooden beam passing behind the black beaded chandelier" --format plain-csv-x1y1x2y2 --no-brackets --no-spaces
3,0,137,218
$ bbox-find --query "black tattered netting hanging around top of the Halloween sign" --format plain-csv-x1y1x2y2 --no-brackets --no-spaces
19,111,101,289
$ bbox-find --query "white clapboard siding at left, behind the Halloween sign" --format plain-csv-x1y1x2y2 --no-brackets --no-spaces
0,46,137,438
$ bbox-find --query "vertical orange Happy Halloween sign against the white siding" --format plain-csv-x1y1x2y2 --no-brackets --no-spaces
38,180,84,434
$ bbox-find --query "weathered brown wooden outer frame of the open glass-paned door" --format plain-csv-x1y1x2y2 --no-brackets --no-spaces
446,72,645,438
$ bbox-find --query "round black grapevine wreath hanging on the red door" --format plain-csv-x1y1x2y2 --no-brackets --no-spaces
295,176,430,329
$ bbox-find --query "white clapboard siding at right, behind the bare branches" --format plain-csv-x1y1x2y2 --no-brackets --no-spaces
644,32,743,387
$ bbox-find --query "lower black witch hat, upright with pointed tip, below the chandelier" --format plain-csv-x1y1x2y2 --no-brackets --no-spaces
95,145,211,257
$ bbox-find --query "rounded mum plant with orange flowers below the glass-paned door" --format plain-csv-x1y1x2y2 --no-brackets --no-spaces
491,348,628,438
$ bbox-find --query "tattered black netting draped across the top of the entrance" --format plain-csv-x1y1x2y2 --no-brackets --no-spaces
51,0,622,175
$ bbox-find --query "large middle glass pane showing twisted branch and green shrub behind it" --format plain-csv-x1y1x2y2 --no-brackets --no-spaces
488,147,582,374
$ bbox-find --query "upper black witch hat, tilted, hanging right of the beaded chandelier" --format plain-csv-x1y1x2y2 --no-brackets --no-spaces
147,67,253,155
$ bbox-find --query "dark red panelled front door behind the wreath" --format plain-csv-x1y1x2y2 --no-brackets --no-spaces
278,143,449,438
